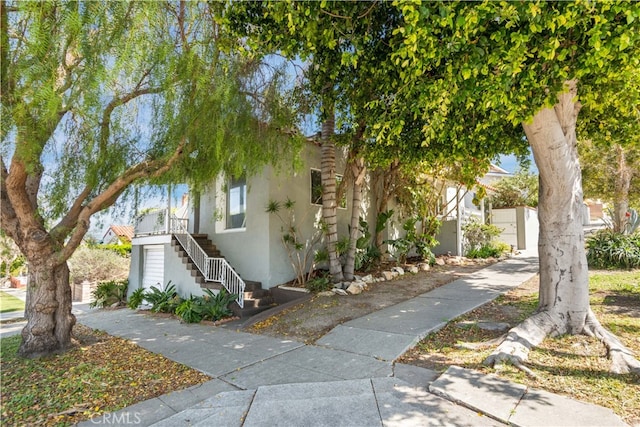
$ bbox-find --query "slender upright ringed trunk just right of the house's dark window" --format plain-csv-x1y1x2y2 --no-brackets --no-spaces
321,106,344,282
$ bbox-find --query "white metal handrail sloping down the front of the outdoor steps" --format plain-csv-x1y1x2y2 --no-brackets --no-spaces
172,217,246,308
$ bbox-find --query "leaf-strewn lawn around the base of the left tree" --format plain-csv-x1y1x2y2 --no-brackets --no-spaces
0,325,210,426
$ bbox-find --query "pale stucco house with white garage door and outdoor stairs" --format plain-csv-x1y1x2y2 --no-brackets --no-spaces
129,140,524,315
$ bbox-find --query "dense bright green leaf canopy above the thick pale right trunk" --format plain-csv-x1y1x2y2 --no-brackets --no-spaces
370,1,640,159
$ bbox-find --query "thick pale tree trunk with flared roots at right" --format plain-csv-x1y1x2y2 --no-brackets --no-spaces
485,81,640,372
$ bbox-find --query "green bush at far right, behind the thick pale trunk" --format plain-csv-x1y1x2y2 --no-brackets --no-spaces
587,229,640,268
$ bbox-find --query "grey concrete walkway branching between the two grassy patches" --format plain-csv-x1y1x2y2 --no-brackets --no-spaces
3,254,625,427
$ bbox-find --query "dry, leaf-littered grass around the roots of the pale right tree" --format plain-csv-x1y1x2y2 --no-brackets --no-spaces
401,270,640,425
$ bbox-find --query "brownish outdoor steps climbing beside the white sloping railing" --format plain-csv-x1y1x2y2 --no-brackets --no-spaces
171,234,277,318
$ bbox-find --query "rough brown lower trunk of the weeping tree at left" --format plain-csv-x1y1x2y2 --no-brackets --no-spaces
18,259,76,357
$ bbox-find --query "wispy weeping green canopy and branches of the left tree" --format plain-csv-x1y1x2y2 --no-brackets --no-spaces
1,2,296,258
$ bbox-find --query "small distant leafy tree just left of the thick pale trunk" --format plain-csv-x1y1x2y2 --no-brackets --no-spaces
489,169,538,209
